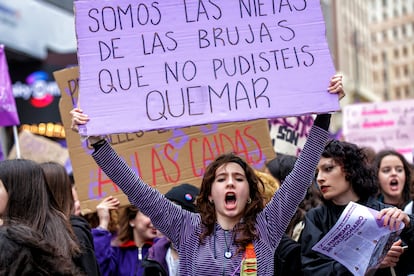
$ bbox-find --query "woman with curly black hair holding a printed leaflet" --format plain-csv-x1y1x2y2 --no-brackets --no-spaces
300,140,414,275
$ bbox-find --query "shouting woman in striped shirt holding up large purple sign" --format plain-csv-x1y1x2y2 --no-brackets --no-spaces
71,75,344,275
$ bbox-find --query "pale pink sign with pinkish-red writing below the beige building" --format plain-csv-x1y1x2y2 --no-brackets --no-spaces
343,100,414,162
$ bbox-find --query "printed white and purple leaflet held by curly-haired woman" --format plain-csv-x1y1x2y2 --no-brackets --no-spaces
312,201,404,276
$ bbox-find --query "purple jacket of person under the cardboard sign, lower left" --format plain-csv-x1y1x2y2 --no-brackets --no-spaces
92,228,151,276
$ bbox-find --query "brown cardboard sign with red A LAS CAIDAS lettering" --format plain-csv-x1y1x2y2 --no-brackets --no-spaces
54,67,275,213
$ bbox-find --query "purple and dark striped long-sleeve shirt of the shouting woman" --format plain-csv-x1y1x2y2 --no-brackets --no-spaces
92,125,329,275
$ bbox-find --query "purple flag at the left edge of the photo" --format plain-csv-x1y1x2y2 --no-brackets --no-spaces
0,45,20,126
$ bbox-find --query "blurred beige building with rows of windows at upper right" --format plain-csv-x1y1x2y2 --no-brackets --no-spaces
323,0,414,102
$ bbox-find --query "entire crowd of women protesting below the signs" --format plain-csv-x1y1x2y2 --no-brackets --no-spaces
0,75,414,276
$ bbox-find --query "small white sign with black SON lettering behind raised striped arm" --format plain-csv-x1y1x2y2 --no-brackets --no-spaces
269,115,313,156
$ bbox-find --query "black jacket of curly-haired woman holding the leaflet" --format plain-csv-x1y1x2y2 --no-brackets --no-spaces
300,198,414,276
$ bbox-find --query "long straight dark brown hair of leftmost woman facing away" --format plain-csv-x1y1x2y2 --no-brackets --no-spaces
0,159,80,257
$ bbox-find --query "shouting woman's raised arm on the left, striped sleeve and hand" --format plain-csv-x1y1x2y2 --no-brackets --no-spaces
71,108,199,248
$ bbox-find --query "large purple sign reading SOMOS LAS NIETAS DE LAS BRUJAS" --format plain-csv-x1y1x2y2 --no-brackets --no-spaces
74,0,339,135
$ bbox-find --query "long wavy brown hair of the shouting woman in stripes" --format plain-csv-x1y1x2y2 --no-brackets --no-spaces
197,153,264,251
